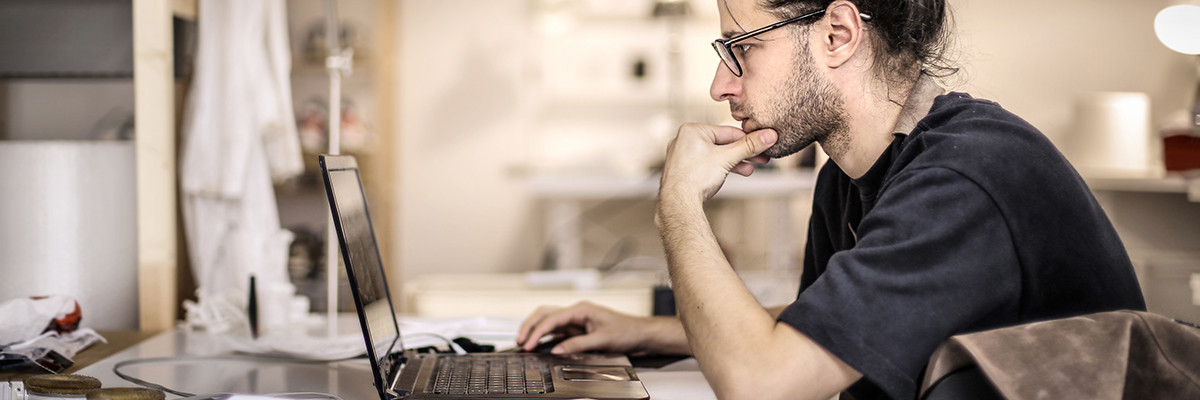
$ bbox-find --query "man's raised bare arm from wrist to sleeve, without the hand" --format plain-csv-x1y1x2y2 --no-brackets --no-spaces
655,193,862,399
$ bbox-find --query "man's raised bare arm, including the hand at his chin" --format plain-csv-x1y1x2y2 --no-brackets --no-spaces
655,125,862,399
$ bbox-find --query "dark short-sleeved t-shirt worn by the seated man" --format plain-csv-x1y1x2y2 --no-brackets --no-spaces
779,94,1146,400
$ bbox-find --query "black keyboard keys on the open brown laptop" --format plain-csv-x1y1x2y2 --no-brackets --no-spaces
427,357,554,394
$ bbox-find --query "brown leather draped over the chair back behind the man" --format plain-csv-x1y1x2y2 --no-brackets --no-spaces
920,311,1200,400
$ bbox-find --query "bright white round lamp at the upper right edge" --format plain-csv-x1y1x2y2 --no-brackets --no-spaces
1154,0,1200,136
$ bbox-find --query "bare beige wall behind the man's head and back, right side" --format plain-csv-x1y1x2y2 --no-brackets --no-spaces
950,0,1195,141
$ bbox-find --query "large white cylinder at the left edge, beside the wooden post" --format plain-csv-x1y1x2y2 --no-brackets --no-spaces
0,141,138,330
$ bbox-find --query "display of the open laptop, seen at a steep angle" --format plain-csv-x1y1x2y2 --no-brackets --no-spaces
322,156,400,382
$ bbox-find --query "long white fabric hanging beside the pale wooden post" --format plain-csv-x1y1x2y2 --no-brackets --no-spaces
180,0,304,333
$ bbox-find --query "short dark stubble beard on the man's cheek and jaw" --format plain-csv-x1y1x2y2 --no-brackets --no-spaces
730,50,850,159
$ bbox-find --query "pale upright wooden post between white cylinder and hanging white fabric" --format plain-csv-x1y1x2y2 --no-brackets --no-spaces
133,0,178,332
